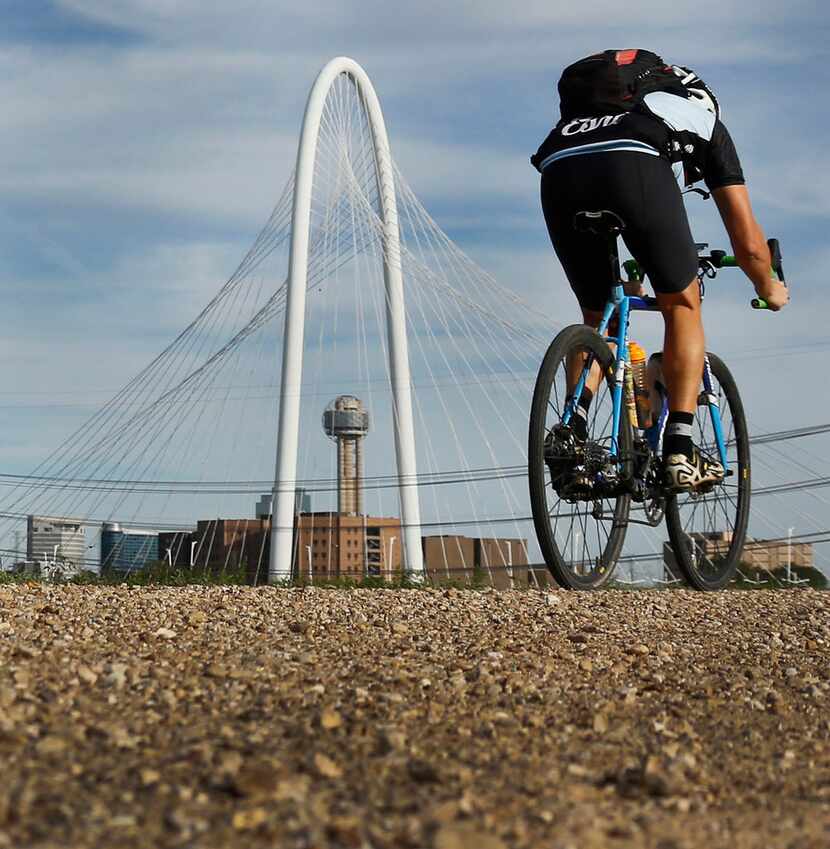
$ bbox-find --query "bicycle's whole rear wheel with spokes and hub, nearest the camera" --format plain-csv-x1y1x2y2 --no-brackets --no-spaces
528,325,632,589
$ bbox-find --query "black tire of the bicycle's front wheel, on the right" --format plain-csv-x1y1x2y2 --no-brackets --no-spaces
666,354,751,591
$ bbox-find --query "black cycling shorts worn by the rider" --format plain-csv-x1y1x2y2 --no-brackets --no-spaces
542,151,698,311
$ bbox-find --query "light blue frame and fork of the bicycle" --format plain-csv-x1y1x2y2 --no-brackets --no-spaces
562,285,729,472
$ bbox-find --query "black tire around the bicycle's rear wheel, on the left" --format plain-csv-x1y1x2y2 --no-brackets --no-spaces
528,325,633,590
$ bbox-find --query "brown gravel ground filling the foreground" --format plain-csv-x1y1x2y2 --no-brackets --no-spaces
0,585,830,849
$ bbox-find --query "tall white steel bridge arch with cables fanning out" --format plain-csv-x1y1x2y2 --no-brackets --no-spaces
268,56,424,581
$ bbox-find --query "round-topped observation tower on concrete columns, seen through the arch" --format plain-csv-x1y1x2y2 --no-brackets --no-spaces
323,395,369,516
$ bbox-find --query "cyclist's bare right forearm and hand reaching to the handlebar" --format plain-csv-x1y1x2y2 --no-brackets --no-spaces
712,186,790,310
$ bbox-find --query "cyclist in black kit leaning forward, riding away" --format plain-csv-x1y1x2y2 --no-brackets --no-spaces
531,50,788,490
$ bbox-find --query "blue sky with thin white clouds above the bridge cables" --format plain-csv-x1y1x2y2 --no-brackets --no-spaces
0,0,830,568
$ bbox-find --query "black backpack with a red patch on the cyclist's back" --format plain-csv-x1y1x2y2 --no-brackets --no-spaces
559,50,688,120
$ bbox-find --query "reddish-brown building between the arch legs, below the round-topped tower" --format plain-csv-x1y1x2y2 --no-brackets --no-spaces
294,513,402,581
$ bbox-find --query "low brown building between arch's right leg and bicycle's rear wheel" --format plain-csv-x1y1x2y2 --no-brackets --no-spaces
423,535,530,589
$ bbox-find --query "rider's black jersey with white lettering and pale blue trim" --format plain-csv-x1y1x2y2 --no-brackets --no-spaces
530,91,745,189
